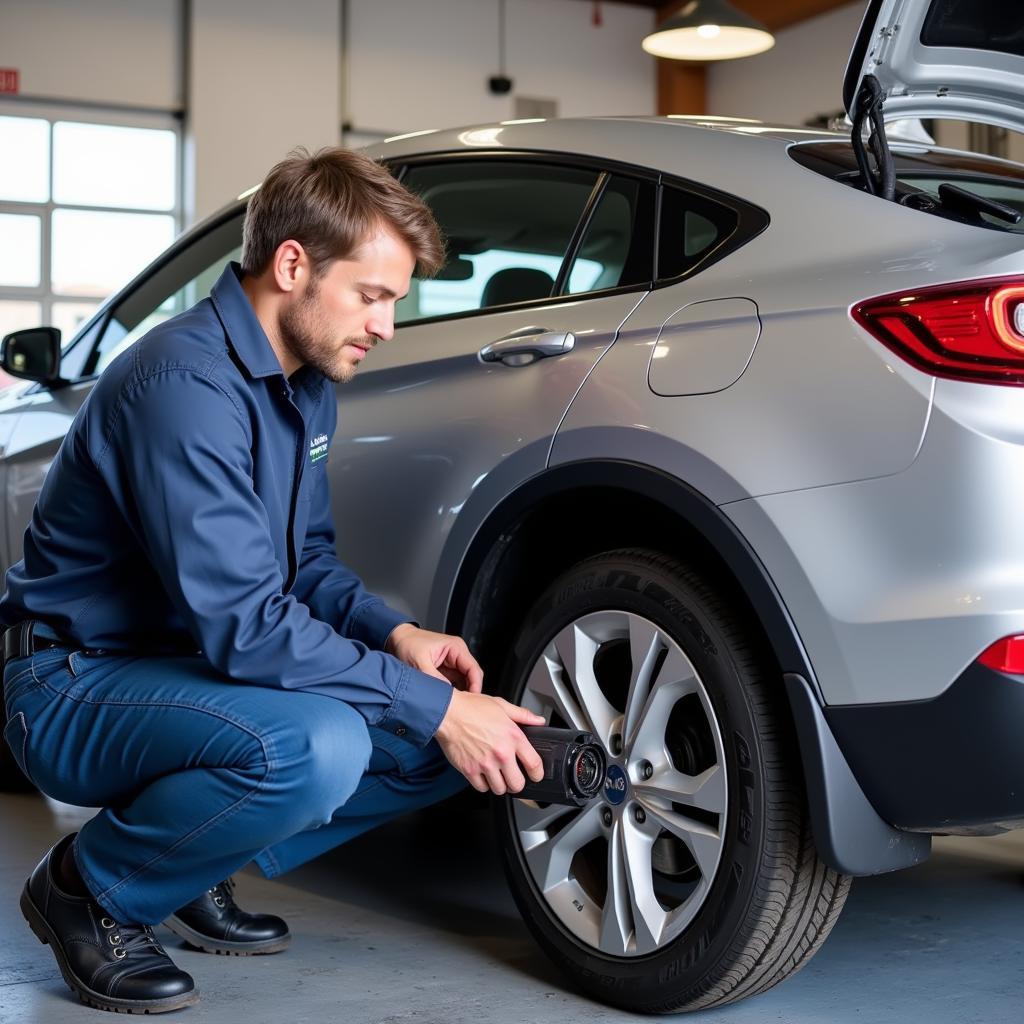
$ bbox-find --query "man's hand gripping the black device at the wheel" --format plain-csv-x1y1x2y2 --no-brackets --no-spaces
434,691,545,796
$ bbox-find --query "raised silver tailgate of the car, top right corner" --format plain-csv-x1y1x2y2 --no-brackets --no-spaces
843,0,1024,132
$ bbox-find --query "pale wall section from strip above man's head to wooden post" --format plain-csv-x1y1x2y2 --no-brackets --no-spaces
346,0,656,135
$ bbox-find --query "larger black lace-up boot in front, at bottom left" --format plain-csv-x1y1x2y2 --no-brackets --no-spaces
22,833,199,1014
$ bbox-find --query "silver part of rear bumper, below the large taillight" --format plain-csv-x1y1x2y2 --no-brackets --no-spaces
723,372,1024,705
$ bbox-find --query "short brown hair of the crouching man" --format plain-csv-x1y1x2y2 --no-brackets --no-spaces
242,146,444,276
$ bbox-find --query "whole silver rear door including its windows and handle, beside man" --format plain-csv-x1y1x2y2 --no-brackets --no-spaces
330,154,654,628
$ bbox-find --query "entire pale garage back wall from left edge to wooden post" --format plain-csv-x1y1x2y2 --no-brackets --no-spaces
0,0,656,224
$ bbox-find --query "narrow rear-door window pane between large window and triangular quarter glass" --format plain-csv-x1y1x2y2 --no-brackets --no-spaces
564,175,655,295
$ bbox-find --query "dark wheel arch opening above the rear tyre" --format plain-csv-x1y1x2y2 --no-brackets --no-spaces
444,459,816,687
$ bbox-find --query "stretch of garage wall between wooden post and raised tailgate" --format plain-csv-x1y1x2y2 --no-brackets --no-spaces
707,0,864,125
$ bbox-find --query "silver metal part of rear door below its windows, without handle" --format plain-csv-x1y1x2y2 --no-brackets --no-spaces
330,292,643,625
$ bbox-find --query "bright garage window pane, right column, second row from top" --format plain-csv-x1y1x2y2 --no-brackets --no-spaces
52,210,174,296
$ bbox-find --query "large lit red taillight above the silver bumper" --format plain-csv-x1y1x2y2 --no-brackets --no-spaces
852,278,1024,385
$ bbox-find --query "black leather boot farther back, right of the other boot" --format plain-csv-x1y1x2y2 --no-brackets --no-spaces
164,879,292,956
